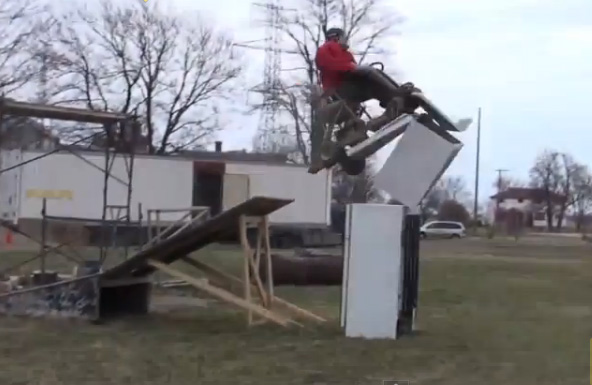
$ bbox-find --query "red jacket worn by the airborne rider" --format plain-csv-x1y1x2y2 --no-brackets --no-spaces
315,41,356,91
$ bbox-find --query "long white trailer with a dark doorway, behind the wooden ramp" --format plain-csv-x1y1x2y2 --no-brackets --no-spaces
0,150,331,226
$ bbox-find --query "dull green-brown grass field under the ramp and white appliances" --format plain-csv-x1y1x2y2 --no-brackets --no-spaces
0,238,592,385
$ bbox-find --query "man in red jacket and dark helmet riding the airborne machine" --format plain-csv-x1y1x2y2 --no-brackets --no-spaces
311,28,402,169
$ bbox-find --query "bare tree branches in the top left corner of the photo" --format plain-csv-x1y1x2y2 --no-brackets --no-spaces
0,0,48,95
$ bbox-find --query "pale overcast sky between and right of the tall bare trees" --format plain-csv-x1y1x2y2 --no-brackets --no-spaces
164,0,592,196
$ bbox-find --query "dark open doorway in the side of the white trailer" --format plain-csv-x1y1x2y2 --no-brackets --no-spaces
193,162,226,215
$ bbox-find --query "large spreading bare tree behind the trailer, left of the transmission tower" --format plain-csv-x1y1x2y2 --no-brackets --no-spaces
44,1,241,153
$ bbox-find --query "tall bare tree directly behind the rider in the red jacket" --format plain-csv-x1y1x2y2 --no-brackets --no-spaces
252,0,402,164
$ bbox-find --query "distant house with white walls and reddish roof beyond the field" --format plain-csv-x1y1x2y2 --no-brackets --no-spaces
487,187,568,227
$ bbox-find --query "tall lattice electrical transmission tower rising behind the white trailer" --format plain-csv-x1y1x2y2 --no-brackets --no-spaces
254,0,284,151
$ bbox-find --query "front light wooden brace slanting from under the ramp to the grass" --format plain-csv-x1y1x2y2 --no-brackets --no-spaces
148,260,291,327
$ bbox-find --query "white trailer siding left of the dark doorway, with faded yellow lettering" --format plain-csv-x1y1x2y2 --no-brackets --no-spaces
19,151,193,220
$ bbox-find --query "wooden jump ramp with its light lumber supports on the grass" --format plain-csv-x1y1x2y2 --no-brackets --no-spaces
103,197,325,326
